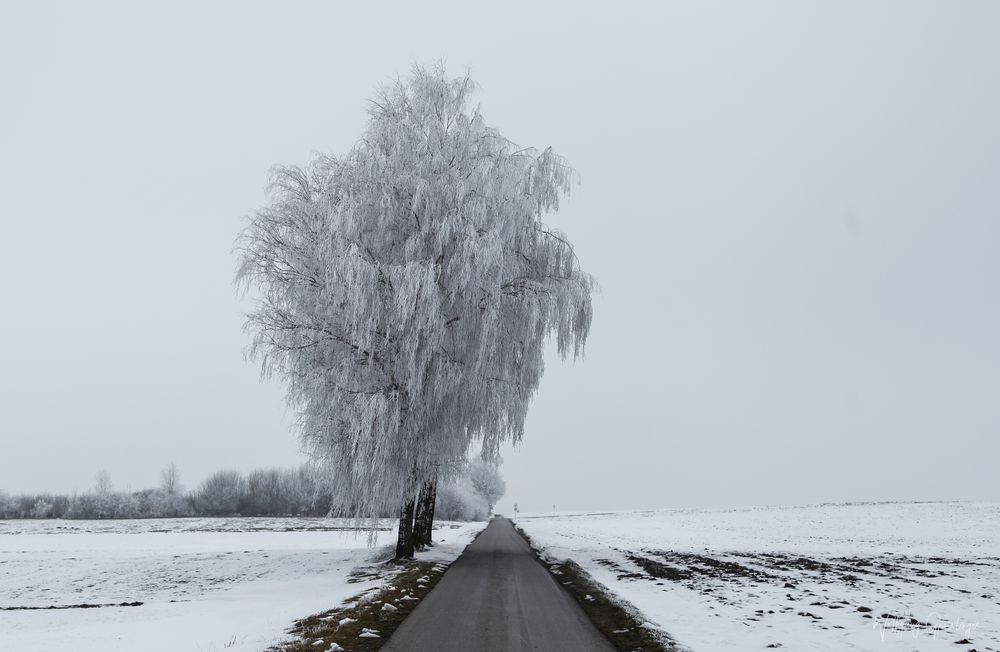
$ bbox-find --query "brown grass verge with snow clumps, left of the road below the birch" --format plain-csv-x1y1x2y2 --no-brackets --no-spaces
268,561,448,652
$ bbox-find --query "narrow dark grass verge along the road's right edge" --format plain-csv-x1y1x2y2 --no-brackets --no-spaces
515,526,684,652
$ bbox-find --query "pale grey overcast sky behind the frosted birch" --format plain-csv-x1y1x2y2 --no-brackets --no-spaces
0,0,1000,510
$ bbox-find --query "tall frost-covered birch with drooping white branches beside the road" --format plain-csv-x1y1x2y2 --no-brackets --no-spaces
237,67,593,556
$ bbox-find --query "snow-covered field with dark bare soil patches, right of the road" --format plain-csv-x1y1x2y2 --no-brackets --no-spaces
517,503,1000,652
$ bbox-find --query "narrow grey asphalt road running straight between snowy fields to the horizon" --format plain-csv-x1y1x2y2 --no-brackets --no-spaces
382,518,615,652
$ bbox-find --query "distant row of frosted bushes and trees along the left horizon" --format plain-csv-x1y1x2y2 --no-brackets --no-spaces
0,464,332,519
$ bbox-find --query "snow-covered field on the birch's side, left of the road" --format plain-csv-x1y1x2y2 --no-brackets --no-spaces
0,518,485,652
